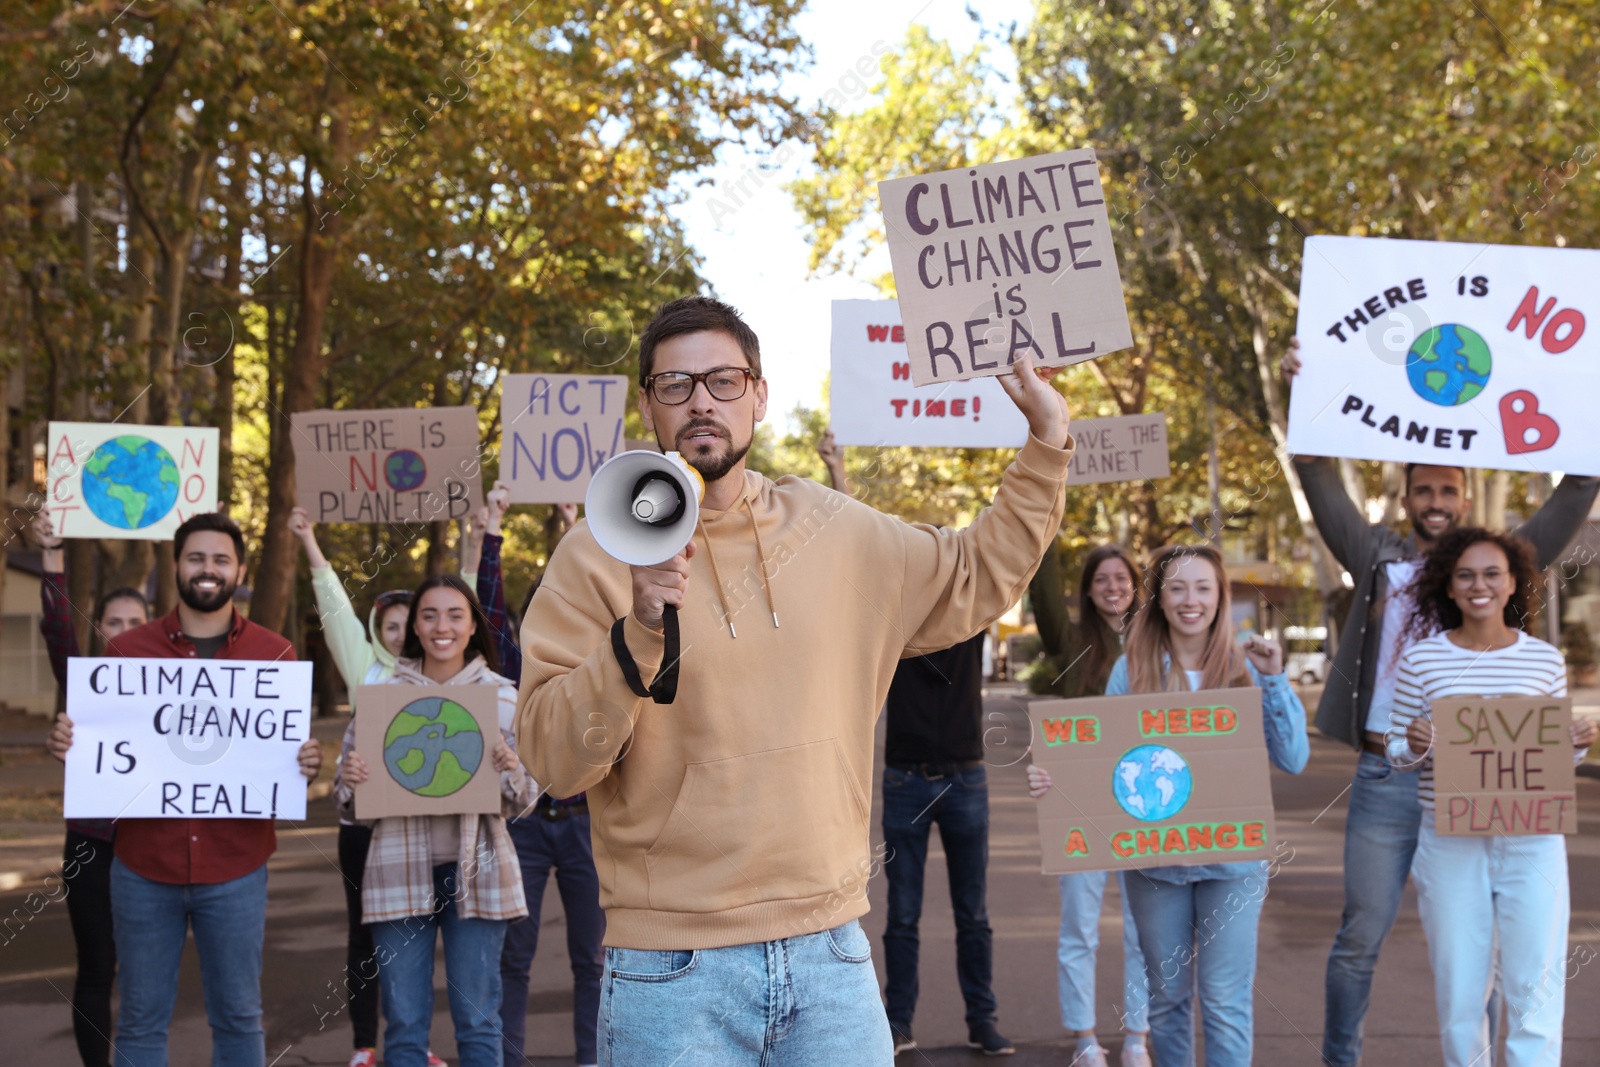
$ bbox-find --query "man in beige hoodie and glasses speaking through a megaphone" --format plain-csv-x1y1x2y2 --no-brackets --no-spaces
517,296,1072,1067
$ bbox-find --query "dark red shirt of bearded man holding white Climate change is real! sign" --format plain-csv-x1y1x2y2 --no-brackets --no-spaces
106,608,294,885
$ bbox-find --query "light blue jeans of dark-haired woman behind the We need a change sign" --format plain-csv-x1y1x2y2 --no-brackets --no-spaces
1056,870,1150,1033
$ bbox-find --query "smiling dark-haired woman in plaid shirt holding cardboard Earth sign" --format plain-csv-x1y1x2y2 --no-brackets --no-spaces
334,574,539,1067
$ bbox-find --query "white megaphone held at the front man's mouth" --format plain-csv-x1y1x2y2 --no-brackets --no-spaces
584,450,706,566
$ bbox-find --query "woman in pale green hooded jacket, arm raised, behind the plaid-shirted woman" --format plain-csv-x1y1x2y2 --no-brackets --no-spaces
290,507,422,1067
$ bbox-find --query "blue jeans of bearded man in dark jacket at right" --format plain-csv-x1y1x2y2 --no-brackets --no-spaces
1322,752,1422,1067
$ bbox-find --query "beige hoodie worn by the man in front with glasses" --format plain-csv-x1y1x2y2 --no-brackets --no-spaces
515,437,1072,950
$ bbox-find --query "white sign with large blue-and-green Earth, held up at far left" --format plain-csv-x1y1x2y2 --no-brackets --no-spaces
45,422,218,541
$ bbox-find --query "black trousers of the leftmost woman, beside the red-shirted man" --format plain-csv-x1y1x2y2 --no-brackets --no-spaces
61,830,117,1067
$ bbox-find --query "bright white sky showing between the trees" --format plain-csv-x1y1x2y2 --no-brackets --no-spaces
677,0,1032,432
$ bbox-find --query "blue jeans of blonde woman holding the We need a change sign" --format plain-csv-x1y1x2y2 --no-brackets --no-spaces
1126,870,1267,1067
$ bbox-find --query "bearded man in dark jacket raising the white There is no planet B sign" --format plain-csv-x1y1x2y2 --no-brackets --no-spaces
1283,341,1600,1067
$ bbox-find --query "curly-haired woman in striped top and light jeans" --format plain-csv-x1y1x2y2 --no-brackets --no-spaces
1387,528,1597,1067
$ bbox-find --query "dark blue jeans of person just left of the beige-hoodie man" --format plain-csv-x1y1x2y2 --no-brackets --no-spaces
501,814,605,1064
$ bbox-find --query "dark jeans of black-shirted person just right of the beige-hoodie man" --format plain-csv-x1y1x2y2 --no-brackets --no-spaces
883,766,995,1029
